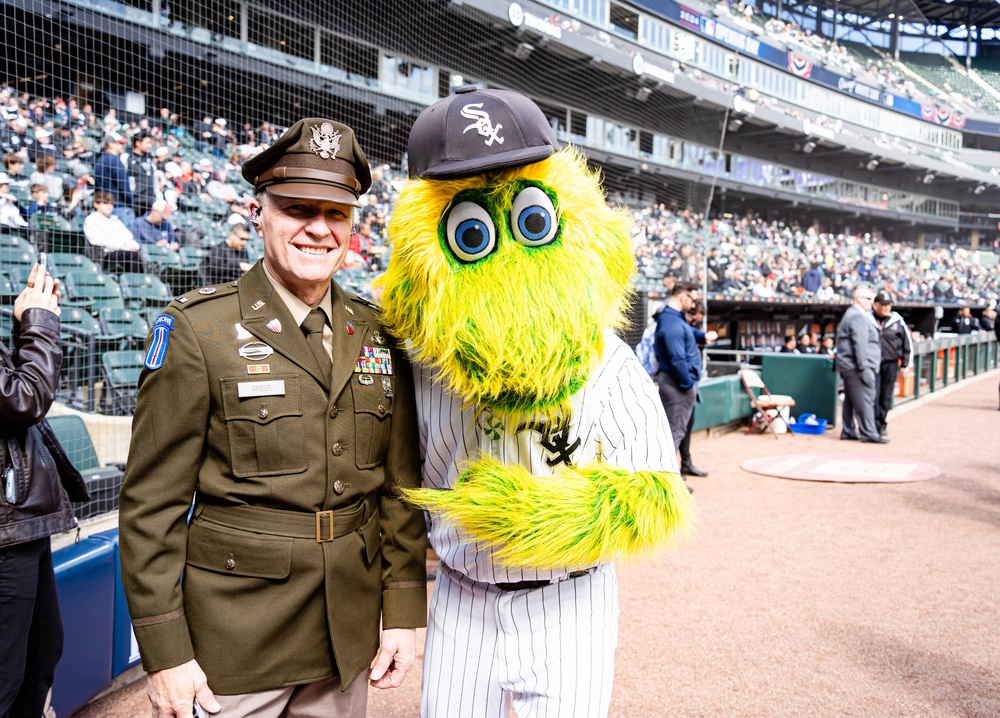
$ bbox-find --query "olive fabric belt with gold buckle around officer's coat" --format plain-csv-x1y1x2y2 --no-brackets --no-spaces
195,499,375,543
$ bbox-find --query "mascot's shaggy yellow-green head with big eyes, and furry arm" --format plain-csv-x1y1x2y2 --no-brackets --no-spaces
382,136,693,569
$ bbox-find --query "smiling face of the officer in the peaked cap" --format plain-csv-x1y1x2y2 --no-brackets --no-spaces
257,195,353,306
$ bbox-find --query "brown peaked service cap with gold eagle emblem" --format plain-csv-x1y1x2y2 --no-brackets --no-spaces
243,118,372,207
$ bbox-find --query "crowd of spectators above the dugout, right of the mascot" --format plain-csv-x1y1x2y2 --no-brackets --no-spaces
632,204,1000,305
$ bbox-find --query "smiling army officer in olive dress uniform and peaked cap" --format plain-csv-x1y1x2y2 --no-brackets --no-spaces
120,119,427,718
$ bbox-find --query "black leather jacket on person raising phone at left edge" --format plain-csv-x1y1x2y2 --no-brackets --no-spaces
0,308,86,547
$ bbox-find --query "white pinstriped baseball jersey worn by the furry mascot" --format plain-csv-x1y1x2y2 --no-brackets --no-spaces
413,332,677,583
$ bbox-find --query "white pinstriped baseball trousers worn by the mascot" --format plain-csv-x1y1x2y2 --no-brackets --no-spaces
420,563,618,718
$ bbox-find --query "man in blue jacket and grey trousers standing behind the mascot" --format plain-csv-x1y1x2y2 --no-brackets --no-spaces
653,281,701,462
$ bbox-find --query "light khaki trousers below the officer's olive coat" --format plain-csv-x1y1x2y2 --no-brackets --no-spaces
208,672,368,718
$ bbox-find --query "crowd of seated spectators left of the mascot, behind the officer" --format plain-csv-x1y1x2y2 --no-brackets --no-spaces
0,86,403,280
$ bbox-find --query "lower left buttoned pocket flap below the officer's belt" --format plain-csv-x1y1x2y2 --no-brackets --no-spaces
187,519,292,578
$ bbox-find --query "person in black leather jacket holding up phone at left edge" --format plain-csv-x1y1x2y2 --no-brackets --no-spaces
0,264,76,716
